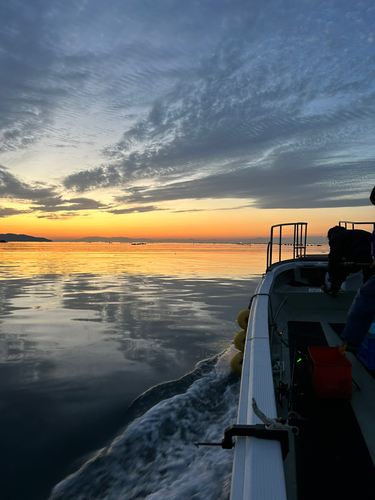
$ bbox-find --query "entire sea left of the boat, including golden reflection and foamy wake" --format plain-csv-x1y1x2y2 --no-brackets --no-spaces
0,243,328,500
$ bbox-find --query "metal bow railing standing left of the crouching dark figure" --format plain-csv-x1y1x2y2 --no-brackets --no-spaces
267,222,307,270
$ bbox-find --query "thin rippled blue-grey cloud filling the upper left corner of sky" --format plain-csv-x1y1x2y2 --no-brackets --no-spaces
0,0,234,153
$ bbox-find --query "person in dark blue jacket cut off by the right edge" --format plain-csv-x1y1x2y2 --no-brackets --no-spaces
341,187,375,348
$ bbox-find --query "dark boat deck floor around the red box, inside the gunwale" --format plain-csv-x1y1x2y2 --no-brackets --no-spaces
271,278,375,500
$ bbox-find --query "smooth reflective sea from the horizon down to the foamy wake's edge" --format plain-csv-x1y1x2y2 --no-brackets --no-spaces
0,243,270,500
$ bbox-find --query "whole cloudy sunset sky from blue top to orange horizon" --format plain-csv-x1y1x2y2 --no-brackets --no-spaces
0,0,375,240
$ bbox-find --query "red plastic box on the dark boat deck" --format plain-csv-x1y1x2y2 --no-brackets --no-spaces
308,346,352,399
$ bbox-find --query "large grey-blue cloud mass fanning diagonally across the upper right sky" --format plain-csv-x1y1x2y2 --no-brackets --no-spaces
58,2,375,208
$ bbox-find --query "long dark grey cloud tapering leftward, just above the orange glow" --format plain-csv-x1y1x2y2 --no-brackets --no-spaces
115,153,375,209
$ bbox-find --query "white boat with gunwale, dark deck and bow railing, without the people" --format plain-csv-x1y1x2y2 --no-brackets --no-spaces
231,221,375,500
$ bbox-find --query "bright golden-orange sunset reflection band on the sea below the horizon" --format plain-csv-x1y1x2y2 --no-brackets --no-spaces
0,242,272,279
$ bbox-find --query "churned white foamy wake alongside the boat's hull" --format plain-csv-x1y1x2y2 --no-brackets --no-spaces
50,348,239,500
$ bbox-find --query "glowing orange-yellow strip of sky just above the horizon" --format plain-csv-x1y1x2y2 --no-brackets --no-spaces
1,206,375,241
